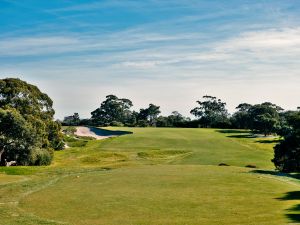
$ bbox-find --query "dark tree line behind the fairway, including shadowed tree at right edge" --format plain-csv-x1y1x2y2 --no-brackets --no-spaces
62,95,300,172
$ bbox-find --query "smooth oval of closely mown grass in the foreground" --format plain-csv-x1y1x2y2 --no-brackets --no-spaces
21,165,297,225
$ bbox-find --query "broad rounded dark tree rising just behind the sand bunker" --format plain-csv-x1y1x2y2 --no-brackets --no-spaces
91,95,132,125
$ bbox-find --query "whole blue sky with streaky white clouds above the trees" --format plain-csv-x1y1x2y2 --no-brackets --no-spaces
0,0,300,118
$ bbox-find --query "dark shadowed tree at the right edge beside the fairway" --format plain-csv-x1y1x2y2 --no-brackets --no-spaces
272,111,300,172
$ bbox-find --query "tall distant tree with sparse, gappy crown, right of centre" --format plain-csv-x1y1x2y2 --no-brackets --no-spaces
191,95,230,128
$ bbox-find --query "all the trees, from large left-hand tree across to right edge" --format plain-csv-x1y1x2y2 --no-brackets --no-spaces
0,78,300,172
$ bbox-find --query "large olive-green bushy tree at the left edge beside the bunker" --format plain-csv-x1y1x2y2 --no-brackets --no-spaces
0,78,64,165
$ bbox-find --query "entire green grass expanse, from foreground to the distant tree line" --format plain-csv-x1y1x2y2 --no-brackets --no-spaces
0,128,300,225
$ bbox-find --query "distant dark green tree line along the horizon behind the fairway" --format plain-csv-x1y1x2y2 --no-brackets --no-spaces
62,95,297,136
